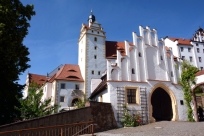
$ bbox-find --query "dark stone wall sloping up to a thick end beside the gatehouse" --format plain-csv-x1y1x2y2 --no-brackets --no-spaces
0,102,117,132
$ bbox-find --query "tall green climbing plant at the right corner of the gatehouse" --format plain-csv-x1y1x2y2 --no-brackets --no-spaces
179,61,199,121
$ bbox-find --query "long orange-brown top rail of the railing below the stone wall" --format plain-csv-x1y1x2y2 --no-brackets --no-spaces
0,121,94,135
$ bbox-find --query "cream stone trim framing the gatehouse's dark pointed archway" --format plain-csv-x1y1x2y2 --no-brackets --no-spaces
148,83,178,123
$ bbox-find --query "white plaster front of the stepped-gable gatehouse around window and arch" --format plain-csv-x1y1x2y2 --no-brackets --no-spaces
91,23,187,122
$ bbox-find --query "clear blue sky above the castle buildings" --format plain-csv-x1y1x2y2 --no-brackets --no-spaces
19,0,204,84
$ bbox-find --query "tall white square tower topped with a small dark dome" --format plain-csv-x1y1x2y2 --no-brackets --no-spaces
78,11,106,97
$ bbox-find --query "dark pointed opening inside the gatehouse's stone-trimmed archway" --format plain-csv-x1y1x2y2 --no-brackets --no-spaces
151,87,173,121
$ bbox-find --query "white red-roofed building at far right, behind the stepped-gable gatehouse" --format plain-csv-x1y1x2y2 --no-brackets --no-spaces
164,28,204,70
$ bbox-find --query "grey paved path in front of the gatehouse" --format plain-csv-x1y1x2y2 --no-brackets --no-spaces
95,121,204,136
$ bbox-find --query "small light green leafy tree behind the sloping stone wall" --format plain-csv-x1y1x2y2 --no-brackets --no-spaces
16,83,58,120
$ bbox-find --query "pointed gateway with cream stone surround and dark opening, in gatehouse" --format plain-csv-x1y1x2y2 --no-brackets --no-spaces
149,83,178,122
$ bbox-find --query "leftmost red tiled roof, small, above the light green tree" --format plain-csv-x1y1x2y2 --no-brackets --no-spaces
28,73,47,86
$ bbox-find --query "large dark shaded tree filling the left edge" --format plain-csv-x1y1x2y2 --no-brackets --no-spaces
0,0,35,125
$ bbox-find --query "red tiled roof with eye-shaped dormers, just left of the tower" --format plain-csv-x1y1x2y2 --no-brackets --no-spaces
49,64,84,82
